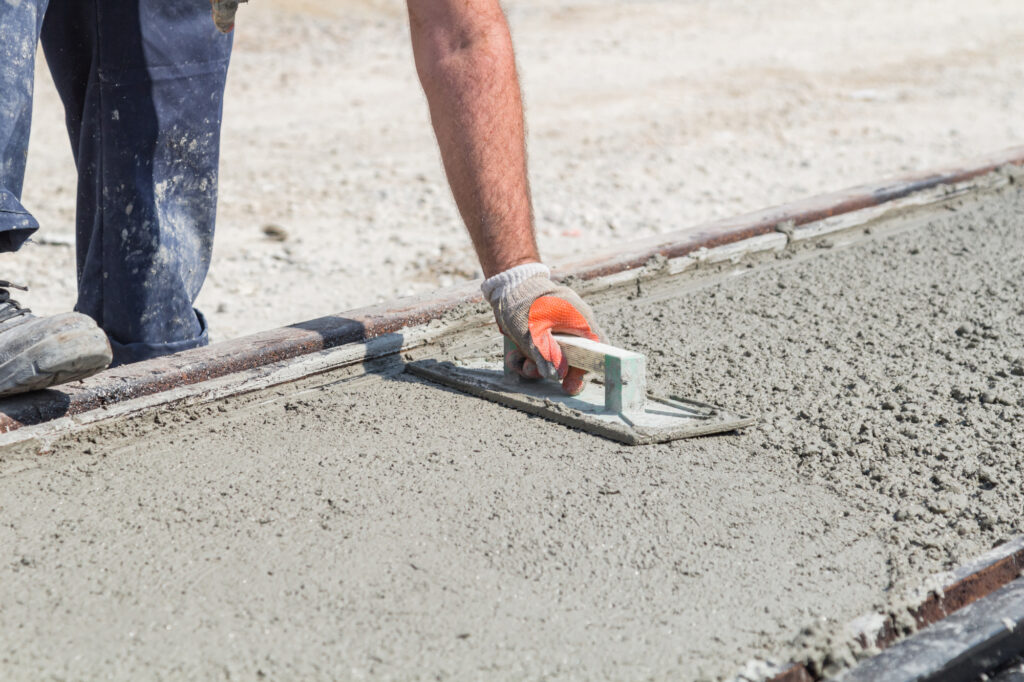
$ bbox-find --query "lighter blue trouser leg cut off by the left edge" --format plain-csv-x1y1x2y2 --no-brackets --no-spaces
0,0,46,250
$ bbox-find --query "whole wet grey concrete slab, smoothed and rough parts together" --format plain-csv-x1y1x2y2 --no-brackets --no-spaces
0,185,1024,679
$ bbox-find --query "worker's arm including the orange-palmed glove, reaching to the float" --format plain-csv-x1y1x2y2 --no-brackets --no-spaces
408,0,601,393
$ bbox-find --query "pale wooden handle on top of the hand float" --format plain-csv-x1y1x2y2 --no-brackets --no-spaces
505,334,647,414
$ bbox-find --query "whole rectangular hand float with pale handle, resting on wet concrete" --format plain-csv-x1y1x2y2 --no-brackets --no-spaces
407,335,756,445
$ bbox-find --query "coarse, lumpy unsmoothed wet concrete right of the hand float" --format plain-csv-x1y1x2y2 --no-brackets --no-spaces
612,188,1024,585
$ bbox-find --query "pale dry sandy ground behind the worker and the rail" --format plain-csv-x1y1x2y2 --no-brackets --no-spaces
6,0,1024,339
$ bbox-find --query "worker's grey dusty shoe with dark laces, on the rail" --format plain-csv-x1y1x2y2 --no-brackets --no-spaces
0,281,114,397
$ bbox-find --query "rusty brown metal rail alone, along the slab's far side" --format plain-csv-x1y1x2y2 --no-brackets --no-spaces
0,147,1024,433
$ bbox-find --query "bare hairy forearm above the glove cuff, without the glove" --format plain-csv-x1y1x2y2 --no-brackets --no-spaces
409,0,539,276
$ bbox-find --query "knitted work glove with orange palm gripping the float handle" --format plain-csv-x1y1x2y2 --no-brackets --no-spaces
481,263,603,395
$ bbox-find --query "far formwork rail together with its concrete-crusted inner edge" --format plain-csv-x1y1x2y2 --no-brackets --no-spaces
0,146,1024,436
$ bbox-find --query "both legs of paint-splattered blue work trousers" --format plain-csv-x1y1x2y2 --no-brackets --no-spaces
0,0,231,364
